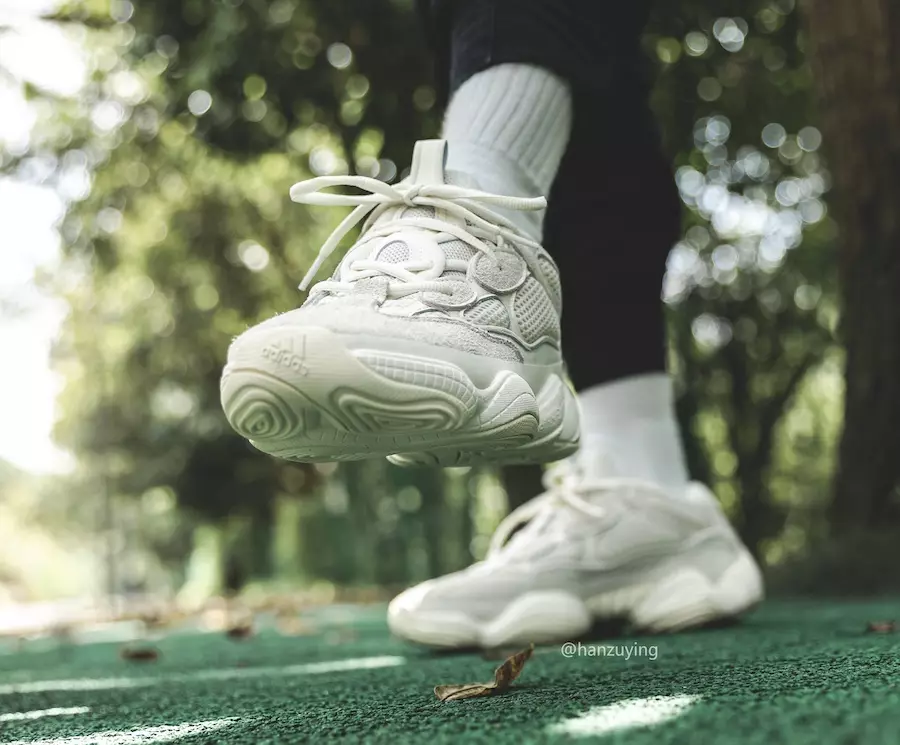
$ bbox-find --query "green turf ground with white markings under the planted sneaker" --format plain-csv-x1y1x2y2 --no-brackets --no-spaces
0,602,900,745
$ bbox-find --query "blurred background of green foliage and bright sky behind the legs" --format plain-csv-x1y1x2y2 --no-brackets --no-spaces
0,0,900,631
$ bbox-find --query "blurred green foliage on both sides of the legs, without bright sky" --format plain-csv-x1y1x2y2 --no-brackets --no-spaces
2,0,839,596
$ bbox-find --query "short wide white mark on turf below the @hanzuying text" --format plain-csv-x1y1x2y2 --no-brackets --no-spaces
547,696,700,737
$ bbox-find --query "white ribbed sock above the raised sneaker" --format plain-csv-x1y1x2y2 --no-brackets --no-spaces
443,64,572,240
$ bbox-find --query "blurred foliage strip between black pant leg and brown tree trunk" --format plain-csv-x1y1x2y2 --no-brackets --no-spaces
645,0,839,561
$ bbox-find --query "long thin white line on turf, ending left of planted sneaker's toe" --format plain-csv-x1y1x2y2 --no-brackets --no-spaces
0,655,406,696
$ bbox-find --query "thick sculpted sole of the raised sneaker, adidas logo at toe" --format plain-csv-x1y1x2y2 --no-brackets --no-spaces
221,327,578,466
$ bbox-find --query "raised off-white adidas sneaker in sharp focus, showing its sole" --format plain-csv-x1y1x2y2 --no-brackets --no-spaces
221,140,578,465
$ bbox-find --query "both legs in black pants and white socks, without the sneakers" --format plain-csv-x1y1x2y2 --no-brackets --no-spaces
431,0,687,493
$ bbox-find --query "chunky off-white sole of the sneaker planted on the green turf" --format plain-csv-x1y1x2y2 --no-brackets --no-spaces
388,548,763,649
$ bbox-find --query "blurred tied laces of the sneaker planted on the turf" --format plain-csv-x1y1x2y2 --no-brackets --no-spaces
485,461,665,561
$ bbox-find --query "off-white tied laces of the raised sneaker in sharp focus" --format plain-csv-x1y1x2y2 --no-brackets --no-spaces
291,176,547,298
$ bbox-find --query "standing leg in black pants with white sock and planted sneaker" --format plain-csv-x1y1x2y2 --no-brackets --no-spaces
388,0,762,647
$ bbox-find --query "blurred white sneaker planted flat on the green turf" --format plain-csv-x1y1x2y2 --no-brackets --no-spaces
388,454,763,648
